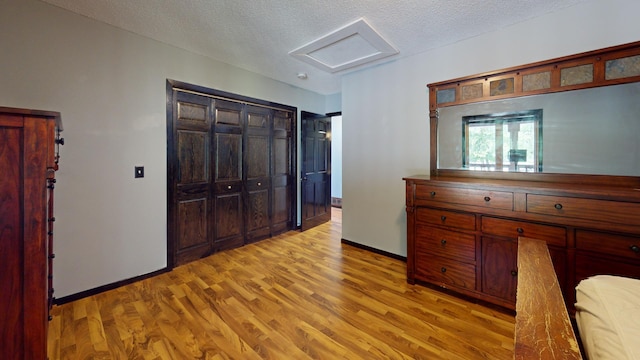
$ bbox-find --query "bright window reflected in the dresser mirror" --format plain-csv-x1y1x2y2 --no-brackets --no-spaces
462,109,542,172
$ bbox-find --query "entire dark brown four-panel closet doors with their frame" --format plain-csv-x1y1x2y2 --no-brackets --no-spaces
167,80,297,268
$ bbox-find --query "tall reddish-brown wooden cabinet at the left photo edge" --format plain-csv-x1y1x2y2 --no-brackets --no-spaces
0,107,63,359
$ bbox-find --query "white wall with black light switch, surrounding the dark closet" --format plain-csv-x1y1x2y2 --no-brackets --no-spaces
0,0,327,297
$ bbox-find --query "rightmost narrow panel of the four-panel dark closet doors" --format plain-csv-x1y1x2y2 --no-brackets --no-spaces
271,111,295,234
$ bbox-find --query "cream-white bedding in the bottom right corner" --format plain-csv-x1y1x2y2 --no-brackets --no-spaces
575,275,640,360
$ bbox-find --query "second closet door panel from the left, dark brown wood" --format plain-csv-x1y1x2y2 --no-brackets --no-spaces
213,100,245,251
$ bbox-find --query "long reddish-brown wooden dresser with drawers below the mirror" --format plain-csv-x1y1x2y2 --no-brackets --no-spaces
404,176,640,309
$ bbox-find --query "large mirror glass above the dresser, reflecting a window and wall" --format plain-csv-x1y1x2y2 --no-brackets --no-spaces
437,83,640,176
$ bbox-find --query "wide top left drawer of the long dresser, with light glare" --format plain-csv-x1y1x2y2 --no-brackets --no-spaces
416,184,513,210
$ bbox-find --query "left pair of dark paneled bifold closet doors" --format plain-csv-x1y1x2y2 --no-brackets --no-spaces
168,91,245,266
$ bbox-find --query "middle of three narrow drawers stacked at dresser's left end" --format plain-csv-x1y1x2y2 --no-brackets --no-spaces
415,225,476,263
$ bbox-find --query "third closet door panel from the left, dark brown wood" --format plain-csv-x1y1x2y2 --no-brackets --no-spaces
244,105,273,242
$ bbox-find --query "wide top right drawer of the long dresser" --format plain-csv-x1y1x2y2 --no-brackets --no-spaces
527,194,640,224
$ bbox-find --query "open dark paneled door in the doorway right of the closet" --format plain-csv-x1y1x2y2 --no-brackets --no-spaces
300,111,331,231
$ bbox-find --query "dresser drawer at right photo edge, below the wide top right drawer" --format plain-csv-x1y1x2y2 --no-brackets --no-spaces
576,230,640,264
